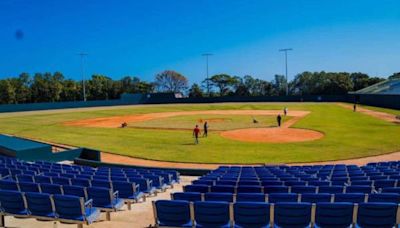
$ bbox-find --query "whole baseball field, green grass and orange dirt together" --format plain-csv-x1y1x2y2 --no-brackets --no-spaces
0,103,400,164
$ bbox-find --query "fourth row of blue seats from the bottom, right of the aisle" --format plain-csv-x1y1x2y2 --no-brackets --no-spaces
192,179,400,189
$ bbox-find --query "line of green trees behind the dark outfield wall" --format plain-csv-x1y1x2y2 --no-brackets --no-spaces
0,70,400,104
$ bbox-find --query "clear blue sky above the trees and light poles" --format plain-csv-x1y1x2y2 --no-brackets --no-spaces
0,0,400,82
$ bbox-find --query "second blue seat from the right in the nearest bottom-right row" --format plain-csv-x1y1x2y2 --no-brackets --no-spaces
314,203,353,228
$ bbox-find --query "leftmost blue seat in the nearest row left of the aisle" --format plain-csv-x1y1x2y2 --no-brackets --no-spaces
0,190,29,217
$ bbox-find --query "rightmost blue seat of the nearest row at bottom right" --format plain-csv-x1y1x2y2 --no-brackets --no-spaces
357,203,398,228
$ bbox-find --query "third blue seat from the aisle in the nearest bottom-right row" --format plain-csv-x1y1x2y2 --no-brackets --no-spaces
233,202,270,228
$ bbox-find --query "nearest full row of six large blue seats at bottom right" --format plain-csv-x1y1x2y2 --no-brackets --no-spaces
153,200,398,228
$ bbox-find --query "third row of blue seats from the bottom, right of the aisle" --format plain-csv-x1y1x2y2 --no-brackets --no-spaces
183,185,388,194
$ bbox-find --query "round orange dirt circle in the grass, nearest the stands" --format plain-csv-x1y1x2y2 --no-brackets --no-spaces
220,127,324,143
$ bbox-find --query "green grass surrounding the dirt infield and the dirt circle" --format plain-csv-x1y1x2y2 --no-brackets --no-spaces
0,103,400,163
